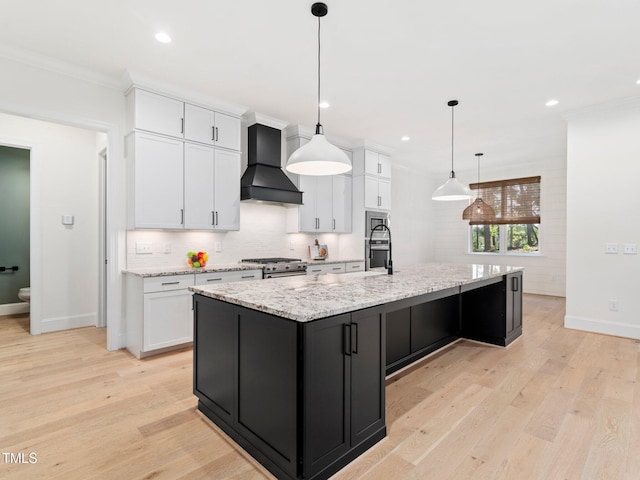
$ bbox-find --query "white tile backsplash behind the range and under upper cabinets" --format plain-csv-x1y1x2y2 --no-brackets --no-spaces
127,202,364,268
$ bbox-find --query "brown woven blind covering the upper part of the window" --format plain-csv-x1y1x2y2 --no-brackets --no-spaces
469,177,541,225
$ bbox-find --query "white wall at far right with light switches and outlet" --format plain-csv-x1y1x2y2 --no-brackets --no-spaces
565,98,640,338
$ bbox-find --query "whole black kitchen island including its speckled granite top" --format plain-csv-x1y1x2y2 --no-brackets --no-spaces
191,264,522,479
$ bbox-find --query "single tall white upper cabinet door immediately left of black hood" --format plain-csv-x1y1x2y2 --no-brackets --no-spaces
213,150,240,230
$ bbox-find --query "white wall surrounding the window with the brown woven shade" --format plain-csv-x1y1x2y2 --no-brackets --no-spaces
429,158,566,296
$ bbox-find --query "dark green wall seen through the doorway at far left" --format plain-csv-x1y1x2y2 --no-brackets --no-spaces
0,145,29,304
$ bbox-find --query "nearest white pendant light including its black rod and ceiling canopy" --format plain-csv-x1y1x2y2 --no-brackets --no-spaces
285,3,351,176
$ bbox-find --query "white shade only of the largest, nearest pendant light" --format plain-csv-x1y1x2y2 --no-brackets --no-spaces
286,133,351,176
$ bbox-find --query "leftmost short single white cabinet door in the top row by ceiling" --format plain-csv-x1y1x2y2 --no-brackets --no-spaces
134,90,184,137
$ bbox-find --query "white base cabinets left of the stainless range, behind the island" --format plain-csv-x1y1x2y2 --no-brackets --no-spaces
125,270,262,358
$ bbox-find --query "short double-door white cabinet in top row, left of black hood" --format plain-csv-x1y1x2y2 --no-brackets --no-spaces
184,103,240,150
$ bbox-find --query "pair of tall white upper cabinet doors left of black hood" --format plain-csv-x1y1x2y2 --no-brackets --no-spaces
184,143,240,230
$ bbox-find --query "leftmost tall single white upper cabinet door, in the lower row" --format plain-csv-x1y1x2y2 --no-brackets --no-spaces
133,133,184,229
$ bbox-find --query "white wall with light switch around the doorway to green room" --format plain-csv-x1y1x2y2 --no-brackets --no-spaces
0,113,98,332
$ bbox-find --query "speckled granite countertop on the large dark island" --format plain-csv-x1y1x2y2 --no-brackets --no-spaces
189,263,523,322
